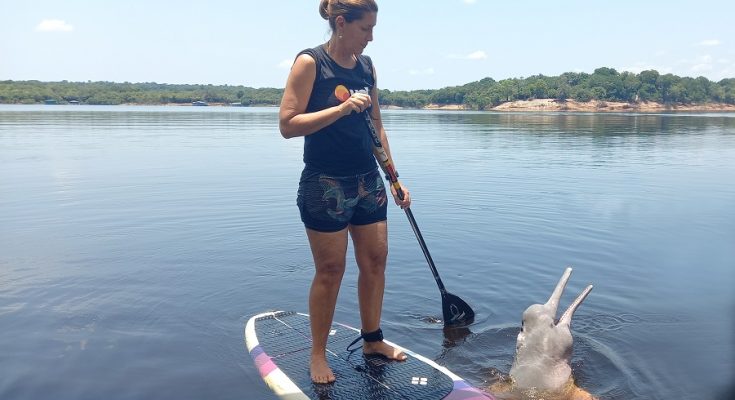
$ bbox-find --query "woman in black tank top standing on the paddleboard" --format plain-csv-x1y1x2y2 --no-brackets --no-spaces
279,0,411,383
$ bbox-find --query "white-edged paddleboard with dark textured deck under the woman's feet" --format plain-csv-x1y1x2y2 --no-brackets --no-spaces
245,311,494,400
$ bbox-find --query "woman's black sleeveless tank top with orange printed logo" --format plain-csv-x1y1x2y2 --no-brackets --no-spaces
299,45,377,176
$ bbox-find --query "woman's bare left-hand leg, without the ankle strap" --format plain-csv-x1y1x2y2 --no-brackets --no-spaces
306,229,347,383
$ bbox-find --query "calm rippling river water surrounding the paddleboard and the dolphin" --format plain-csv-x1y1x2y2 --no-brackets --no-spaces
0,106,735,400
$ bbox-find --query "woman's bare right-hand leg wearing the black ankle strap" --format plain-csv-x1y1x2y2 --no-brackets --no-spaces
350,221,406,360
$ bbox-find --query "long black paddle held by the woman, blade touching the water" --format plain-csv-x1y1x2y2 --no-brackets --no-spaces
364,111,475,326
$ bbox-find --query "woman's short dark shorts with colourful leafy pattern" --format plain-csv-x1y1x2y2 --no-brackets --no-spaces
296,168,388,232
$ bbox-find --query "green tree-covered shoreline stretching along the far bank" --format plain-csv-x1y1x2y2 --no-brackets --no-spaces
0,67,735,110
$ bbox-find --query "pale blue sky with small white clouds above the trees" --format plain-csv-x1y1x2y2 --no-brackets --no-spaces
0,0,735,90
